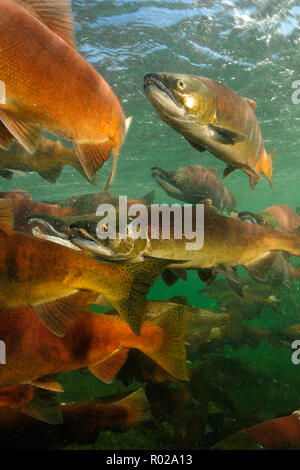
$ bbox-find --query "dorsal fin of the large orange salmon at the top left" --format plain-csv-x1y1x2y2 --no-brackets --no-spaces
15,0,76,49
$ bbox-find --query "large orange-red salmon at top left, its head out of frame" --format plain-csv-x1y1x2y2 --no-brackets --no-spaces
0,0,125,186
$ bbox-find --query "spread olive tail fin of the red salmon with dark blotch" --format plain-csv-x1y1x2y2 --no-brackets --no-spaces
141,305,188,381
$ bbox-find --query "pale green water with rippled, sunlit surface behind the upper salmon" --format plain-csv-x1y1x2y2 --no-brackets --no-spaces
2,0,300,210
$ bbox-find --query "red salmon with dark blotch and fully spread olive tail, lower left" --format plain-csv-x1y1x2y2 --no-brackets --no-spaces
0,305,186,387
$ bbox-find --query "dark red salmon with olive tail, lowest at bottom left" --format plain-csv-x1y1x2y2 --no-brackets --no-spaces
0,385,151,450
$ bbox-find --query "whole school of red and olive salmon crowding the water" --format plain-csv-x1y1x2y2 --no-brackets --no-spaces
0,0,300,449
